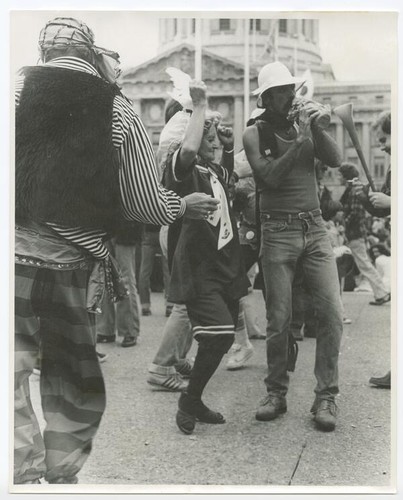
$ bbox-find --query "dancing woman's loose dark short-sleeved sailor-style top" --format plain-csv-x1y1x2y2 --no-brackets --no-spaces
164,150,249,303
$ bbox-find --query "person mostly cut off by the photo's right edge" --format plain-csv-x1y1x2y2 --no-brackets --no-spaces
354,111,392,389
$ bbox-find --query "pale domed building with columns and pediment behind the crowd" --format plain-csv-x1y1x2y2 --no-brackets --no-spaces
120,18,390,189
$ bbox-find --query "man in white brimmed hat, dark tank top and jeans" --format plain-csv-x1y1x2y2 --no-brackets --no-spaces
243,62,343,431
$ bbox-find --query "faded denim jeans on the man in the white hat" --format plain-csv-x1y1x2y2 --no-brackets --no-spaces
261,214,343,397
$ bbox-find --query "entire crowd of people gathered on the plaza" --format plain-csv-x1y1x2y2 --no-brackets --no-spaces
14,18,391,484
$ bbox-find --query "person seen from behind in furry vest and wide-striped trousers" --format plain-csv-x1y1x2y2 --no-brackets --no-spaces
14,17,218,484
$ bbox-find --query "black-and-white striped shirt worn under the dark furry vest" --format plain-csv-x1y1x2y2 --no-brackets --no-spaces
15,57,186,259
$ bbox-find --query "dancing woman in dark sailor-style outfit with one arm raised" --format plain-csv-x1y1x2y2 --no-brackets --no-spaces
164,81,248,434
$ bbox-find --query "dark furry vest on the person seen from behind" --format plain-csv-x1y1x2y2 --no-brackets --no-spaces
15,66,121,232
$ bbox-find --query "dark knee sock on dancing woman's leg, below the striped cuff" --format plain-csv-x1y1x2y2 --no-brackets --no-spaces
186,334,234,399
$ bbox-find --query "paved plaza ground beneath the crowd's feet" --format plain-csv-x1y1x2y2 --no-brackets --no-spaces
22,291,396,493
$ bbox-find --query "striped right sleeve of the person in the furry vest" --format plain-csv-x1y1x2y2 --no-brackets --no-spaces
113,97,186,225
